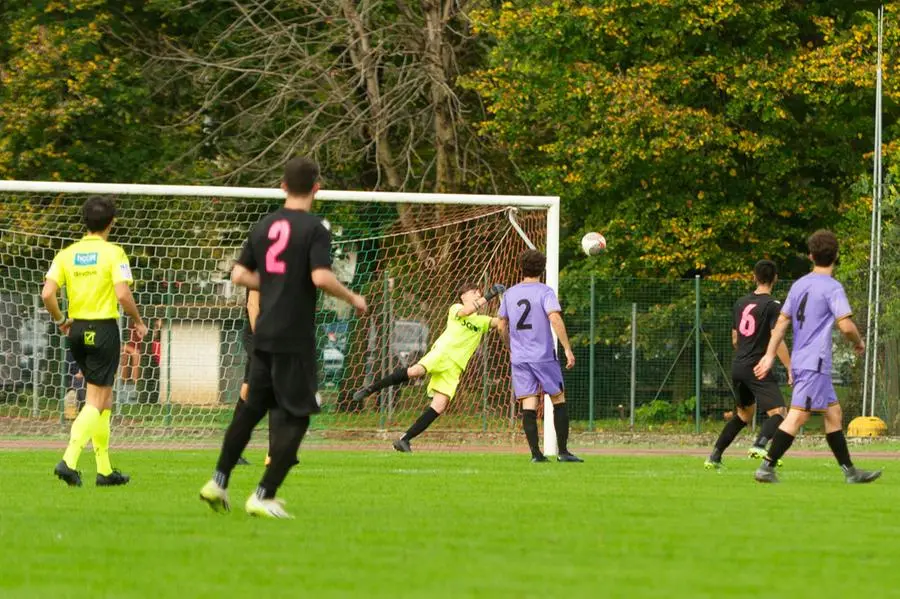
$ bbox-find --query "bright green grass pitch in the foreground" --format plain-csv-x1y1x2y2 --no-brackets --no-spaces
0,450,900,599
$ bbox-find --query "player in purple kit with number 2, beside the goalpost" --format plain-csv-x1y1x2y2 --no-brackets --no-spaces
500,250,584,462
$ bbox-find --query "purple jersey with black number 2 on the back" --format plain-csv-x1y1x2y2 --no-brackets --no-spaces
500,283,562,364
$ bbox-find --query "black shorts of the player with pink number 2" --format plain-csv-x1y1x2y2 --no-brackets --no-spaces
247,350,321,416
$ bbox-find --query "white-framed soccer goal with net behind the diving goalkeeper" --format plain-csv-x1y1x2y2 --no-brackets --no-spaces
0,181,559,455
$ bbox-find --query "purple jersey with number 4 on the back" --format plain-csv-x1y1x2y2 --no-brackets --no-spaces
781,273,853,374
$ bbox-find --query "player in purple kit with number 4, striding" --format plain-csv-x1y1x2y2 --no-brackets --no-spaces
753,231,881,483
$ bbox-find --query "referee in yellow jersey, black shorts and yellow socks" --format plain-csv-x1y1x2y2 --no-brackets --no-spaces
41,197,147,487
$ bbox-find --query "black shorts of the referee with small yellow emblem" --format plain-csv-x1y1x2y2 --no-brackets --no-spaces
69,319,122,387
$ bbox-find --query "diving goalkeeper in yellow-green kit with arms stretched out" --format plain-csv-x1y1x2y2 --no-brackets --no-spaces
353,282,506,452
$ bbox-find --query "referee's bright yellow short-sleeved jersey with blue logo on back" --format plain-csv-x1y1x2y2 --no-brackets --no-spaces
47,235,133,320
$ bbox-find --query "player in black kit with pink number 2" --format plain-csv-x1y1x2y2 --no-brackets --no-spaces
200,158,366,518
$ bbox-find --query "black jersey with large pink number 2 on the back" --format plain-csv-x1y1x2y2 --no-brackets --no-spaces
238,208,331,356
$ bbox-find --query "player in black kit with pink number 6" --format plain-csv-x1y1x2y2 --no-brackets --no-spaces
703,260,791,470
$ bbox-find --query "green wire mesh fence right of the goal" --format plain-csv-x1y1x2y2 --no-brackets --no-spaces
560,273,900,432
